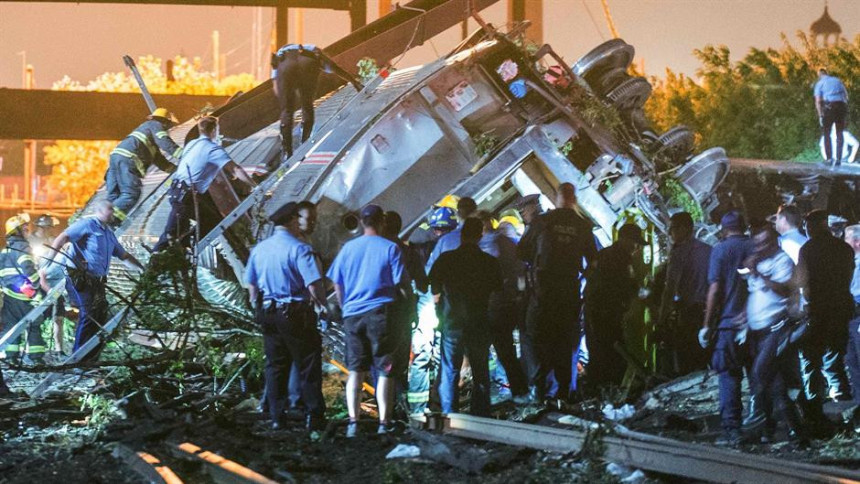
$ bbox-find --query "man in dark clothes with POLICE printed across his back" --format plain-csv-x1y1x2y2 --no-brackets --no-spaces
517,183,597,401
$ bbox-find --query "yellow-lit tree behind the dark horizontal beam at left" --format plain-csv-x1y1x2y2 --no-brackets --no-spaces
45,55,257,206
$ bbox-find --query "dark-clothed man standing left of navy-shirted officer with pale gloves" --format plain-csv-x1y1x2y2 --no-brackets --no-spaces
657,212,711,375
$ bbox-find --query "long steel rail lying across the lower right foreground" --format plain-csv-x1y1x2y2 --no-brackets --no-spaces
413,414,860,484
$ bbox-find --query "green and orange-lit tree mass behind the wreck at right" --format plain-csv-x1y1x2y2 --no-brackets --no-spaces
646,32,860,161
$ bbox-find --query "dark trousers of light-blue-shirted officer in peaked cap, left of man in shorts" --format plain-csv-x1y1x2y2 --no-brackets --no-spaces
256,303,325,422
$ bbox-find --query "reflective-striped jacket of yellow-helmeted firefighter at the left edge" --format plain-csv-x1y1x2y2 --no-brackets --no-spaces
0,233,41,302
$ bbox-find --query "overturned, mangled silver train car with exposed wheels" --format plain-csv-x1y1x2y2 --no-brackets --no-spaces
8,2,729,396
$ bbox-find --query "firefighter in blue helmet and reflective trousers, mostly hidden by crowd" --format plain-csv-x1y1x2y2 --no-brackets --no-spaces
406,207,457,414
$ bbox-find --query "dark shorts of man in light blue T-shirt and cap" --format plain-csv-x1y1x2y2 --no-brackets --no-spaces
343,304,406,377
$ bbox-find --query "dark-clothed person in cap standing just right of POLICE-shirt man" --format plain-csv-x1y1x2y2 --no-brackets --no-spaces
585,224,645,389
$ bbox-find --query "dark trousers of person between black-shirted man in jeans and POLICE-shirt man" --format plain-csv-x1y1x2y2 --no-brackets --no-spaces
489,293,528,396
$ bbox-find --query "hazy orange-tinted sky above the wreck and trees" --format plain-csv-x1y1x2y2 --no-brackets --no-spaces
0,0,860,88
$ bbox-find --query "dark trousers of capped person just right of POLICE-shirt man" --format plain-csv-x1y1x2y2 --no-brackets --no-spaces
585,308,627,388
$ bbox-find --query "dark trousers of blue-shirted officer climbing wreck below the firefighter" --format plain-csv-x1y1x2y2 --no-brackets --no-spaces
153,183,222,252
